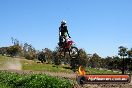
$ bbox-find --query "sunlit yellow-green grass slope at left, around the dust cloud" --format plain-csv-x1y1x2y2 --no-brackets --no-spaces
0,55,72,73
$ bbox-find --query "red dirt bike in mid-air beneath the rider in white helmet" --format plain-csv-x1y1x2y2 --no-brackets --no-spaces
59,38,79,59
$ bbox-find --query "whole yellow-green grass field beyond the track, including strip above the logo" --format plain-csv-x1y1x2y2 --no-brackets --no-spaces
0,55,121,74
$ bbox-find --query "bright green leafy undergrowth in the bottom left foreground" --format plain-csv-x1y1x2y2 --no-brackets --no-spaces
0,71,72,88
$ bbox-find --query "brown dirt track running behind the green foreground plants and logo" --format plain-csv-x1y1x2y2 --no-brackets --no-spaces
1,70,132,88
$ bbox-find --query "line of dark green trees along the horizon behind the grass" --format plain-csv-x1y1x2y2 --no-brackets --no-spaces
0,38,132,71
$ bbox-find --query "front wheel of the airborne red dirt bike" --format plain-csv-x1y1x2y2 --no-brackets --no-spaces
69,46,79,59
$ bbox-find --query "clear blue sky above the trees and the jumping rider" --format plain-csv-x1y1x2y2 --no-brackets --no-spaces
0,0,132,57
